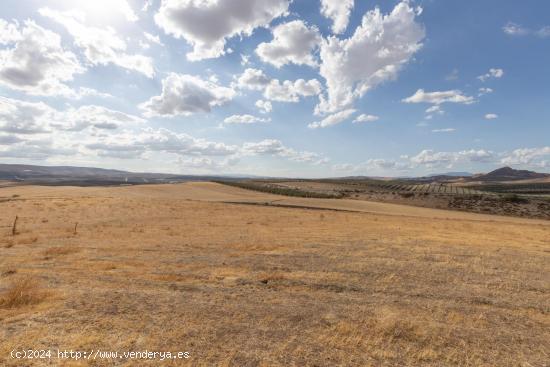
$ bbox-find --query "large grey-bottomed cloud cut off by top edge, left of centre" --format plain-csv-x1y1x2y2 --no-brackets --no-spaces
155,0,289,61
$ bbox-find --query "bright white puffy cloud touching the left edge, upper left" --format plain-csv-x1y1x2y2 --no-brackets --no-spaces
0,20,85,97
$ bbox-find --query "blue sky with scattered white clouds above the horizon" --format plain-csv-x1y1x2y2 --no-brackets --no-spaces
0,0,550,177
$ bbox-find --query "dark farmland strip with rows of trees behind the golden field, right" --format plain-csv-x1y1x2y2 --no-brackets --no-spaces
222,179,550,219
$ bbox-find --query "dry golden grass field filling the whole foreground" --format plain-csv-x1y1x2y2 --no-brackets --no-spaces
0,183,550,367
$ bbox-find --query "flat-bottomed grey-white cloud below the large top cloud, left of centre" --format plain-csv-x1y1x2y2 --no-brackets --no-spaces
139,73,235,117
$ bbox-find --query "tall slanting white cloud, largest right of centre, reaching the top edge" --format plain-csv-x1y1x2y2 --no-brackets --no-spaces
316,1,424,114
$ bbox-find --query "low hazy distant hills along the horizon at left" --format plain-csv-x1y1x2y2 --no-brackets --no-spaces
0,164,248,186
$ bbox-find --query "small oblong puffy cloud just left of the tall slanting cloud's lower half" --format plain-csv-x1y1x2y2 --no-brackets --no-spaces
264,79,321,102
